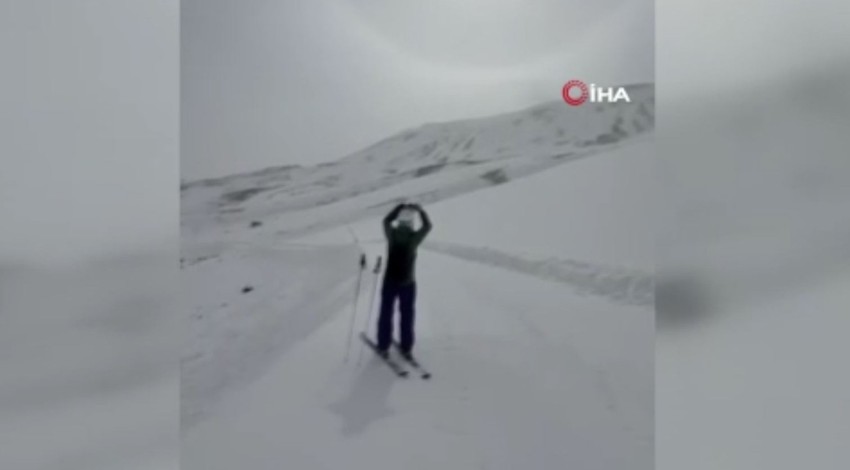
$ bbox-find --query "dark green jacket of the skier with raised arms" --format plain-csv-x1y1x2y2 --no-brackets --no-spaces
384,205,431,284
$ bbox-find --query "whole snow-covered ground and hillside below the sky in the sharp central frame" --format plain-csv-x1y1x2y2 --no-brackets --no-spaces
182,96,654,470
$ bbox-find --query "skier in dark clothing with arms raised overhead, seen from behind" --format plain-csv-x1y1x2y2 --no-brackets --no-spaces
377,204,431,357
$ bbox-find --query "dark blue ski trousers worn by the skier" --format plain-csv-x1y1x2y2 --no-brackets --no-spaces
378,281,416,352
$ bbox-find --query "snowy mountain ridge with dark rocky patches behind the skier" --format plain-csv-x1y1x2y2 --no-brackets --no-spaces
181,85,655,253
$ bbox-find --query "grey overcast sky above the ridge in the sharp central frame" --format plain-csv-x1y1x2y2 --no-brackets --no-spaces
181,0,654,180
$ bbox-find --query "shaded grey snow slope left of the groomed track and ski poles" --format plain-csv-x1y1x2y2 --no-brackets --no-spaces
181,247,356,426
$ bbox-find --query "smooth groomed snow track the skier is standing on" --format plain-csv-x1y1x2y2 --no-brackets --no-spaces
186,247,652,469
